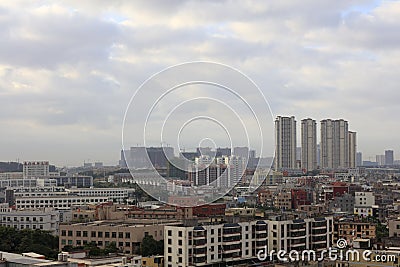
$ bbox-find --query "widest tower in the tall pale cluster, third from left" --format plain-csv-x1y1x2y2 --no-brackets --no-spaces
321,119,349,169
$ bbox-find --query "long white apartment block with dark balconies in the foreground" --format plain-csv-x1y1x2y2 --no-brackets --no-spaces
164,217,333,267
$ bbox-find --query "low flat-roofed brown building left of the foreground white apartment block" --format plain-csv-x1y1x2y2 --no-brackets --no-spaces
59,220,178,254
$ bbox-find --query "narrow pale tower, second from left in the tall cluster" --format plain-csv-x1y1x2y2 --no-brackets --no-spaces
301,119,317,171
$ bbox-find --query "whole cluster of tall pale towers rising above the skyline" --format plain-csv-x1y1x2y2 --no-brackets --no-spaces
275,116,357,171
